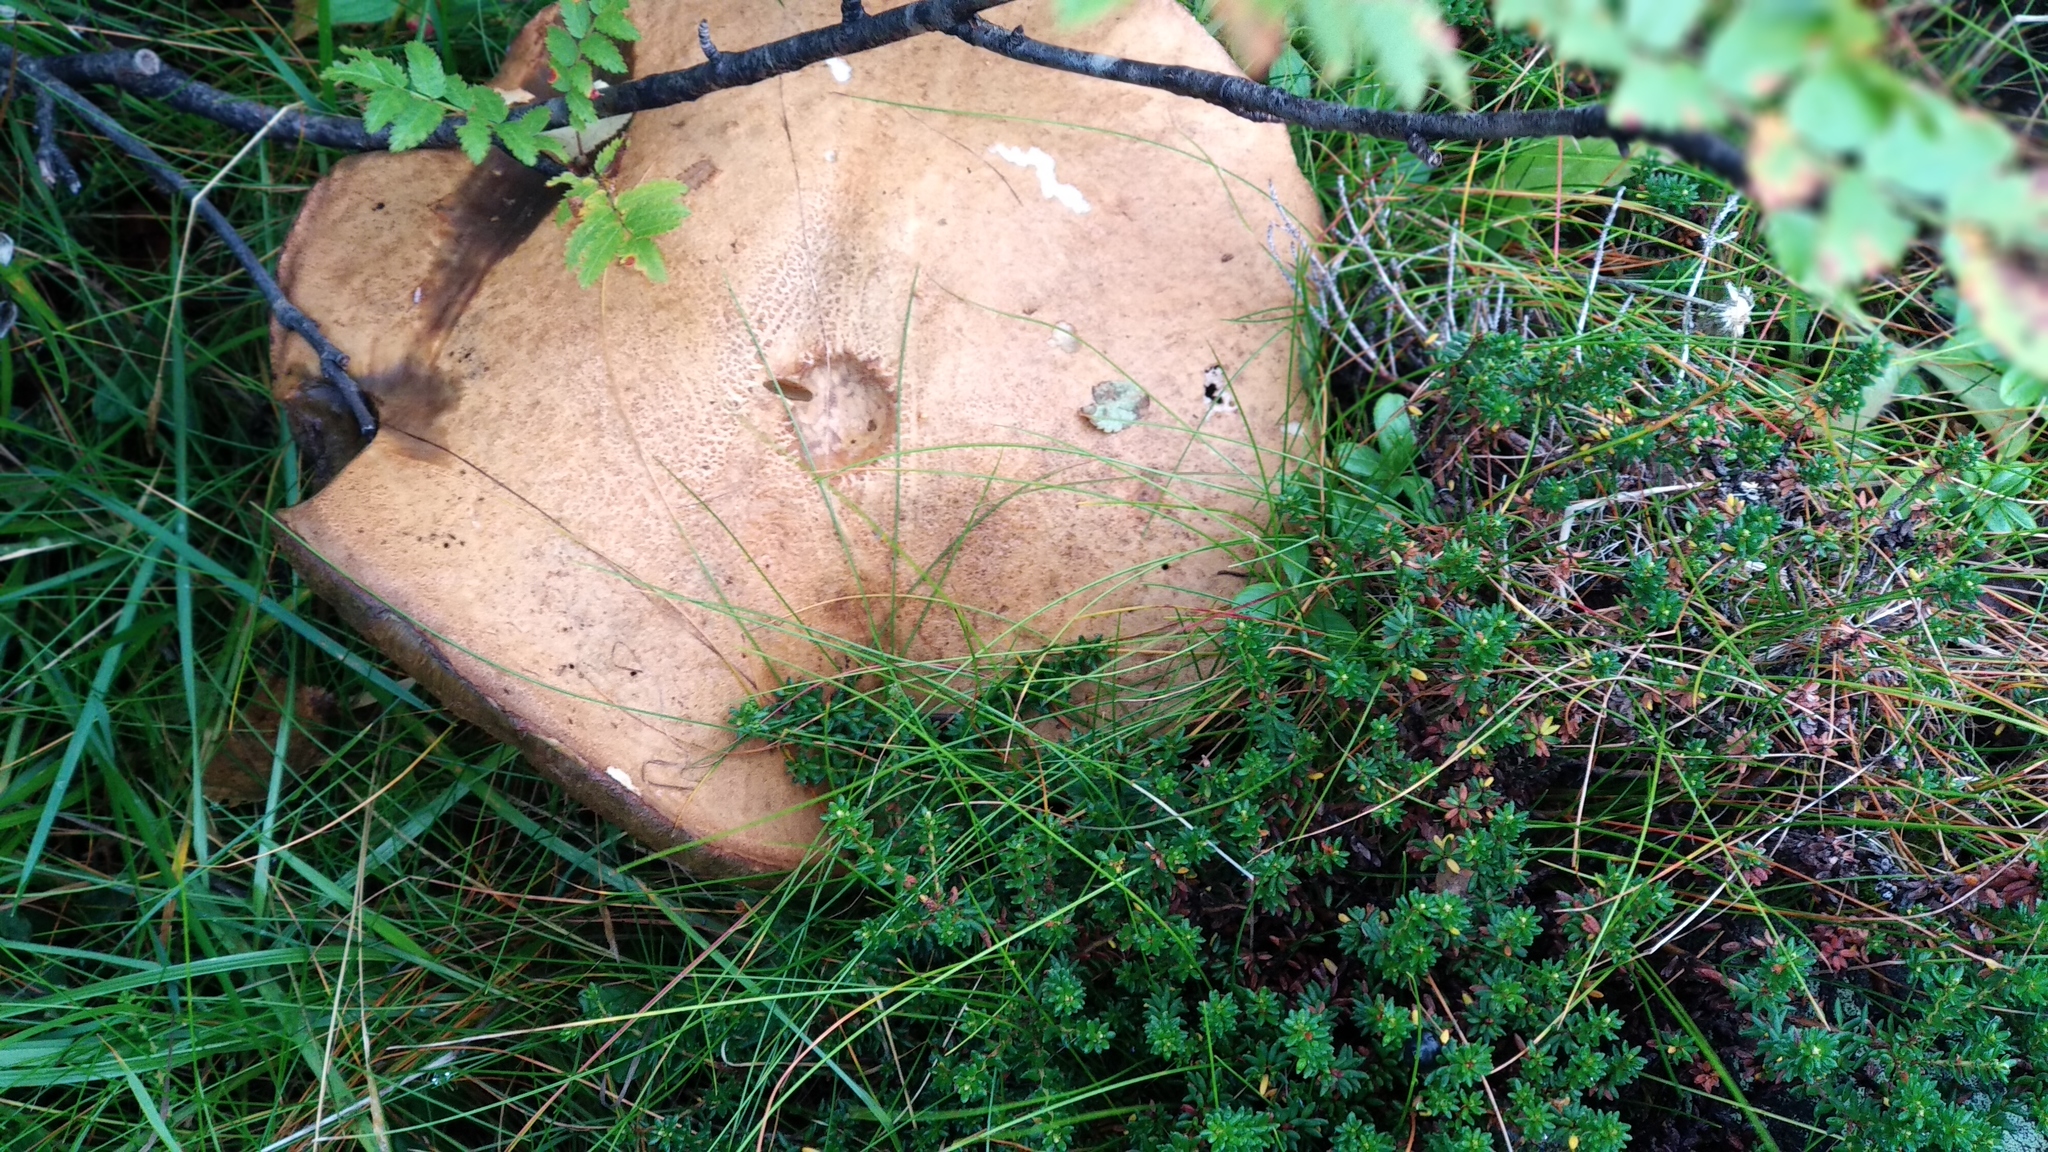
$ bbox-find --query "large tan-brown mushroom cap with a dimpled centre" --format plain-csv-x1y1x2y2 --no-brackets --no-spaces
274,0,1315,871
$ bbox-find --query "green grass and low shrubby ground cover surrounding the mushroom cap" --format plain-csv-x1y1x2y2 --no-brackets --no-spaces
0,0,2048,1152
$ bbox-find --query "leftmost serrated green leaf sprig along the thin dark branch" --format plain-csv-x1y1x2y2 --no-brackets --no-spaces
322,41,569,164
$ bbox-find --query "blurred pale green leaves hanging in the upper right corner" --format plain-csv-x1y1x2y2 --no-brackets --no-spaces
1495,0,2048,377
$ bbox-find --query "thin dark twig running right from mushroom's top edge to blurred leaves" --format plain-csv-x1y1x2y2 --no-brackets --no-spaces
948,18,1747,182
